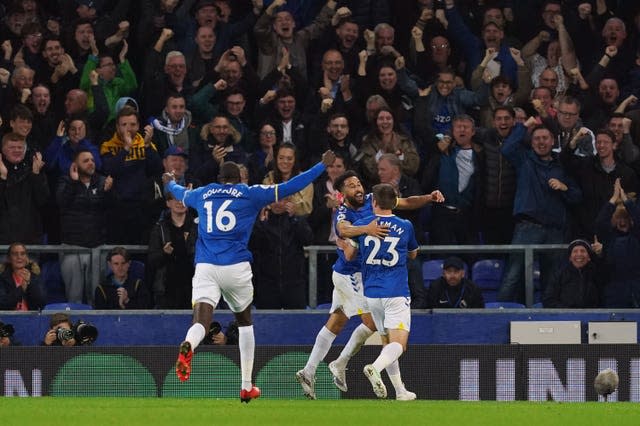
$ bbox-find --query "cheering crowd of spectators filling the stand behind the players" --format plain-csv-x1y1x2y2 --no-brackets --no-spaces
0,0,640,309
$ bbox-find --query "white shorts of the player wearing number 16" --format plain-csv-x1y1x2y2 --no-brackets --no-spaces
191,262,253,312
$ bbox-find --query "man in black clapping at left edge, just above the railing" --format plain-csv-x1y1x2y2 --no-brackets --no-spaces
0,132,50,244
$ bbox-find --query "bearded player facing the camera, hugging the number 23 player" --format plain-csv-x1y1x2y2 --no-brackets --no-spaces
296,170,444,400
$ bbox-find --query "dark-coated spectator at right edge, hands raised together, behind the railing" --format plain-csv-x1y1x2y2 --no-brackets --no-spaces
596,178,640,309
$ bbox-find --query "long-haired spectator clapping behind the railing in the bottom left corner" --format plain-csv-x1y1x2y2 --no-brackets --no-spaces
0,243,47,311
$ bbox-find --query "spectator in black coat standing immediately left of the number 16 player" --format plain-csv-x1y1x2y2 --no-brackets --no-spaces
147,192,198,309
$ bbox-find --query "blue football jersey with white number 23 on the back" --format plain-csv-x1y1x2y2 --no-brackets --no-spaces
354,215,418,298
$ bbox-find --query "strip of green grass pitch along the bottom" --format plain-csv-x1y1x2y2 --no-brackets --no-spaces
0,397,640,426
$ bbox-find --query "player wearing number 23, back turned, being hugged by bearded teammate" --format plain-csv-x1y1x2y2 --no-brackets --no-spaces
343,184,418,398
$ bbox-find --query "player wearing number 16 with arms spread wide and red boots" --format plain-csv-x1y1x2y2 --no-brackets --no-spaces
162,151,335,402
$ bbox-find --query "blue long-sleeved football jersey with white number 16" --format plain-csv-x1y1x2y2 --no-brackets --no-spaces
167,163,325,265
